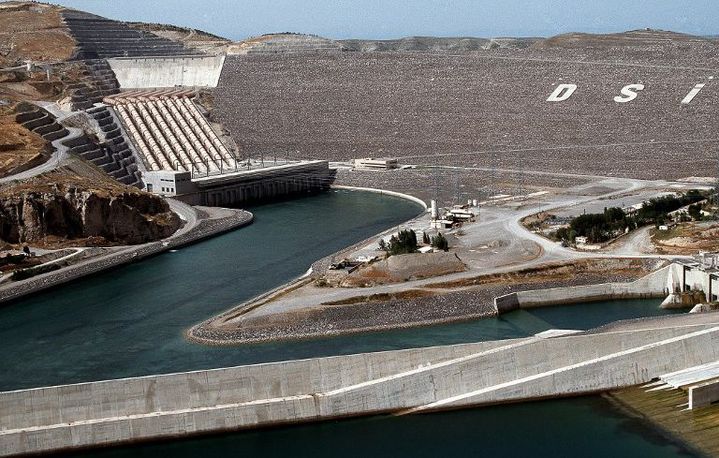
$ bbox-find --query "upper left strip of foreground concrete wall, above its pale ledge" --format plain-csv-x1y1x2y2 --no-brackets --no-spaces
0,340,514,434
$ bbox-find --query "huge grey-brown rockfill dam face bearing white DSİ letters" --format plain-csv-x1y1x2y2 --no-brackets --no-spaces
215,31,719,178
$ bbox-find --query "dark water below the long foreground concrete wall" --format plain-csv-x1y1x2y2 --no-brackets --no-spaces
62,397,694,458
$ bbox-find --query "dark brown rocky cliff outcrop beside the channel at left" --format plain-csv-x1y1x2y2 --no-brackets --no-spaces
0,187,181,245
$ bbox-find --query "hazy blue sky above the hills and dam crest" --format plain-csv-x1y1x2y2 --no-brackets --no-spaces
35,0,719,39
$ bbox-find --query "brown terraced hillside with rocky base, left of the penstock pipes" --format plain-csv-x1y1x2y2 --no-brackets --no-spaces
0,2,204,248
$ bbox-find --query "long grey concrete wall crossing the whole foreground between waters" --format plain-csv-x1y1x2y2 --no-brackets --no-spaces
0,314,719,456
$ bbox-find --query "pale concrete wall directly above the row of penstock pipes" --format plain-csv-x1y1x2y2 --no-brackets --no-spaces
108,56,225,89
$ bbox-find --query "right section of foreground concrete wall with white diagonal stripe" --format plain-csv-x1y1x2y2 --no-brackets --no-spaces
318,328,719,415
